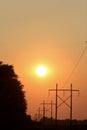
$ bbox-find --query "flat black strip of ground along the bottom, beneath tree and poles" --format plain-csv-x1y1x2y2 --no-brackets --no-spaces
0,120,87,130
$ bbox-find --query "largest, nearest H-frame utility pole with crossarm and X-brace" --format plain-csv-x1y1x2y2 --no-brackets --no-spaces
49,84,80,128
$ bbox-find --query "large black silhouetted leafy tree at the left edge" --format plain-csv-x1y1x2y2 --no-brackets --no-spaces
0,62,27,129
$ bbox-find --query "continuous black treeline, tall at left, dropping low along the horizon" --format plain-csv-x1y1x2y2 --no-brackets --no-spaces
0,62,87,130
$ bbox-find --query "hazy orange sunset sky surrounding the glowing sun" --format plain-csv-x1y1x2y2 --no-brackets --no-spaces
0,0,87,119
